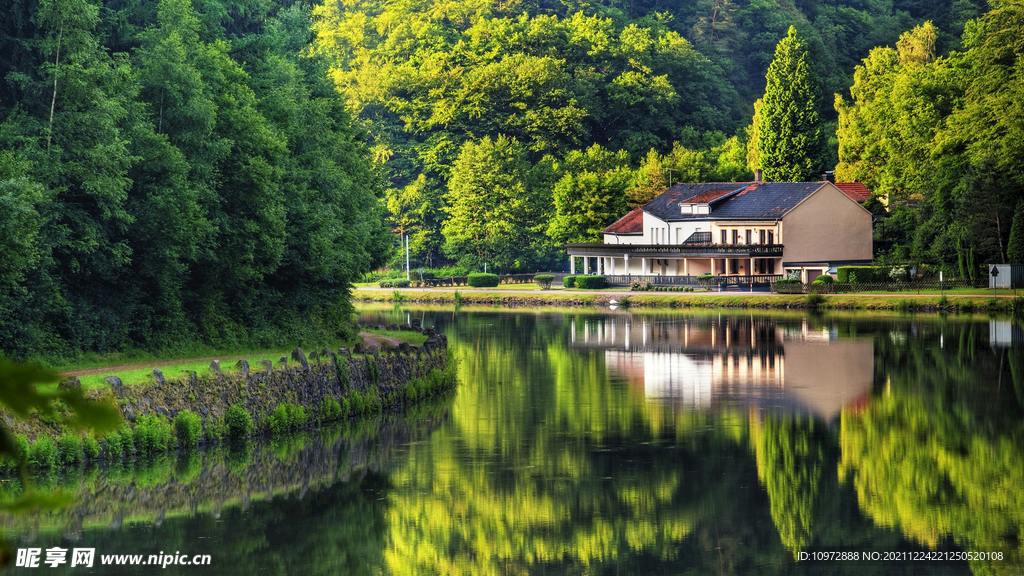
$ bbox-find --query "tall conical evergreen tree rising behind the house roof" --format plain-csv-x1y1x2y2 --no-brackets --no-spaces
757,27,826,181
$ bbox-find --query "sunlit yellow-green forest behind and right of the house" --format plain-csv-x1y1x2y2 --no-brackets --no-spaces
314,0,1024,278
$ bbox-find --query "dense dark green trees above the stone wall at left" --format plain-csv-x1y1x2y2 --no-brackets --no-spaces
0,0,390,358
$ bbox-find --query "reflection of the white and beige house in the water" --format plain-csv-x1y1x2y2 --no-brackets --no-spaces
570,316,874,419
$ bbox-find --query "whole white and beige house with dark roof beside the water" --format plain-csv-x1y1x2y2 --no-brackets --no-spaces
565,176,872,284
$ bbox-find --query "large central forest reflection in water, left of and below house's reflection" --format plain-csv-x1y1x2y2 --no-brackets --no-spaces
385,315,937,574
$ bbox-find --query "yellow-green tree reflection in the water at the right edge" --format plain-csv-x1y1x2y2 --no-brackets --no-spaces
839,323,1024,573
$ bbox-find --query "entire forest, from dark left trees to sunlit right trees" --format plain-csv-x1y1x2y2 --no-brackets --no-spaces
0,0,1024,358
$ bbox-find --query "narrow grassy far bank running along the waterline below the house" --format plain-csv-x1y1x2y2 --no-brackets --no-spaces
352,288,1024,313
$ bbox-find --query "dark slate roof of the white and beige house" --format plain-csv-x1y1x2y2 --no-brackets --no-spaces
643,182,824,221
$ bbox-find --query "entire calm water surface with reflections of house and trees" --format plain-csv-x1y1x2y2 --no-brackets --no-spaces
7,306,1024,575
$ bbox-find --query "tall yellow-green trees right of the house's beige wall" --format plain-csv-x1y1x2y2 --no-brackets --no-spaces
836,11,1024,266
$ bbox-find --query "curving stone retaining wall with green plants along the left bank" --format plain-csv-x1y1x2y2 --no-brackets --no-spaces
0,326,456,468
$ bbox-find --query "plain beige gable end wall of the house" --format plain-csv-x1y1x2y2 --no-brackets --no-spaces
779,183,871,262
